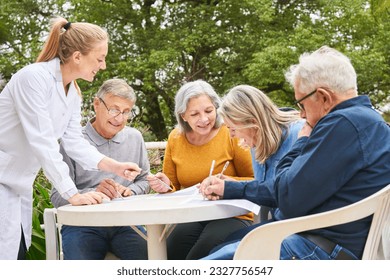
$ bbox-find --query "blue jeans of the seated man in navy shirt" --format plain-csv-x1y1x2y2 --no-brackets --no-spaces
202,234,358,260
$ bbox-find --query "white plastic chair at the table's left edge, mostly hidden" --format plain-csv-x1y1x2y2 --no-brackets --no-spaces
43,208,118,260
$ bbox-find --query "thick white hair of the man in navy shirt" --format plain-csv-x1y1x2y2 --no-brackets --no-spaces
285,46,357,93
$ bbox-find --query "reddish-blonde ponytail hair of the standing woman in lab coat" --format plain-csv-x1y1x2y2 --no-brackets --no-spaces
37,17,108,63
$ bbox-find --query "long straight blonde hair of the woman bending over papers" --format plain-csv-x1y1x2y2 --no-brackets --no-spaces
219,85,300,163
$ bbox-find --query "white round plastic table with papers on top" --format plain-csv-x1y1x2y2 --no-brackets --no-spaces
57,193,258,259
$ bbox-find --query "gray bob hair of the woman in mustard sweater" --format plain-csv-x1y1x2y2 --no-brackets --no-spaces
175,80,222,133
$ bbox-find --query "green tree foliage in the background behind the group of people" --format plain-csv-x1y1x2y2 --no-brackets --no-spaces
0,0,390,140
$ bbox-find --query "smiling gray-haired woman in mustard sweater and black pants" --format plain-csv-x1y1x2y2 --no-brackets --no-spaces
148,80,253,259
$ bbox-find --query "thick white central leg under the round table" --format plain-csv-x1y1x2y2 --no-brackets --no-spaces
146,225,167,260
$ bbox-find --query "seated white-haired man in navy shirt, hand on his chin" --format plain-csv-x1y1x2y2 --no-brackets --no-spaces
201,46,390,260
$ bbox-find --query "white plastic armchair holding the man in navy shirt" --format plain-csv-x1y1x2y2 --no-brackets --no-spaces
234,185,390,260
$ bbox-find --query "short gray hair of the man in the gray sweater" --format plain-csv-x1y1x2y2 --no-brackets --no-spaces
96,79,137,103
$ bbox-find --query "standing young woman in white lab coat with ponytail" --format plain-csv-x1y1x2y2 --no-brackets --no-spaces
0,18,140,259
